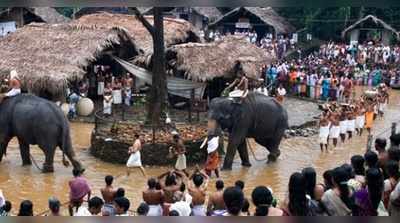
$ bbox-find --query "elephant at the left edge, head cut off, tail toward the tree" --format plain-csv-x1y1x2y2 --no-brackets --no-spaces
0,94,84,173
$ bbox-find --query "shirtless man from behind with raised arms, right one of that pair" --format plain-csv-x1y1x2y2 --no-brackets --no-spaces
188,170,208,216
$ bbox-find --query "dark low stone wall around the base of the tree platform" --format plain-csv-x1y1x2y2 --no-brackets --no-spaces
90,131,207,166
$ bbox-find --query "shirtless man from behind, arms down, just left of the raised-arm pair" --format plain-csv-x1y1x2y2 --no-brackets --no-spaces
143,178,164,216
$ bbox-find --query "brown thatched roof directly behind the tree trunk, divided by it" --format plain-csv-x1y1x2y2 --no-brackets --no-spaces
73,12,200,54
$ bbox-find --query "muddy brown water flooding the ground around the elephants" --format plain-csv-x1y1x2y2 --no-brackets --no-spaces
0,87,400,214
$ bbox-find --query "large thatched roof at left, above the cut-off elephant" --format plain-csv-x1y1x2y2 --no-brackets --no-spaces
0,23,137,99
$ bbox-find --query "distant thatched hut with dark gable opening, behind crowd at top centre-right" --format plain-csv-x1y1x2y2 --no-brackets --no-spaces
209,7,295,34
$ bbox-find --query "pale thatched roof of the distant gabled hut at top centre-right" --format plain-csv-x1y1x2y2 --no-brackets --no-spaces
210,7,295,34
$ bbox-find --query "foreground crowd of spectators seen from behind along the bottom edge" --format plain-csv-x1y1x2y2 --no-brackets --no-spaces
0,134,400,216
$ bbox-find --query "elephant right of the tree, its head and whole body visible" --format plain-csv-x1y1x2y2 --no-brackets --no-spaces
208,92,288,170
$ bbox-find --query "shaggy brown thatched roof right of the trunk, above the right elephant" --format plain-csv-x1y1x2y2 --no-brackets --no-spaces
166,36,275,82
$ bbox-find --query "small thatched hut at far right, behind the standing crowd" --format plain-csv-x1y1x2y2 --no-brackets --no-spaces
342,15,400,44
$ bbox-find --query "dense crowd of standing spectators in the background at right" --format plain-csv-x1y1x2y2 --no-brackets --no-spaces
262,42,400,101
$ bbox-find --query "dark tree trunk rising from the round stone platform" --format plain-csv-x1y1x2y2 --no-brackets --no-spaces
148,7,167,126
